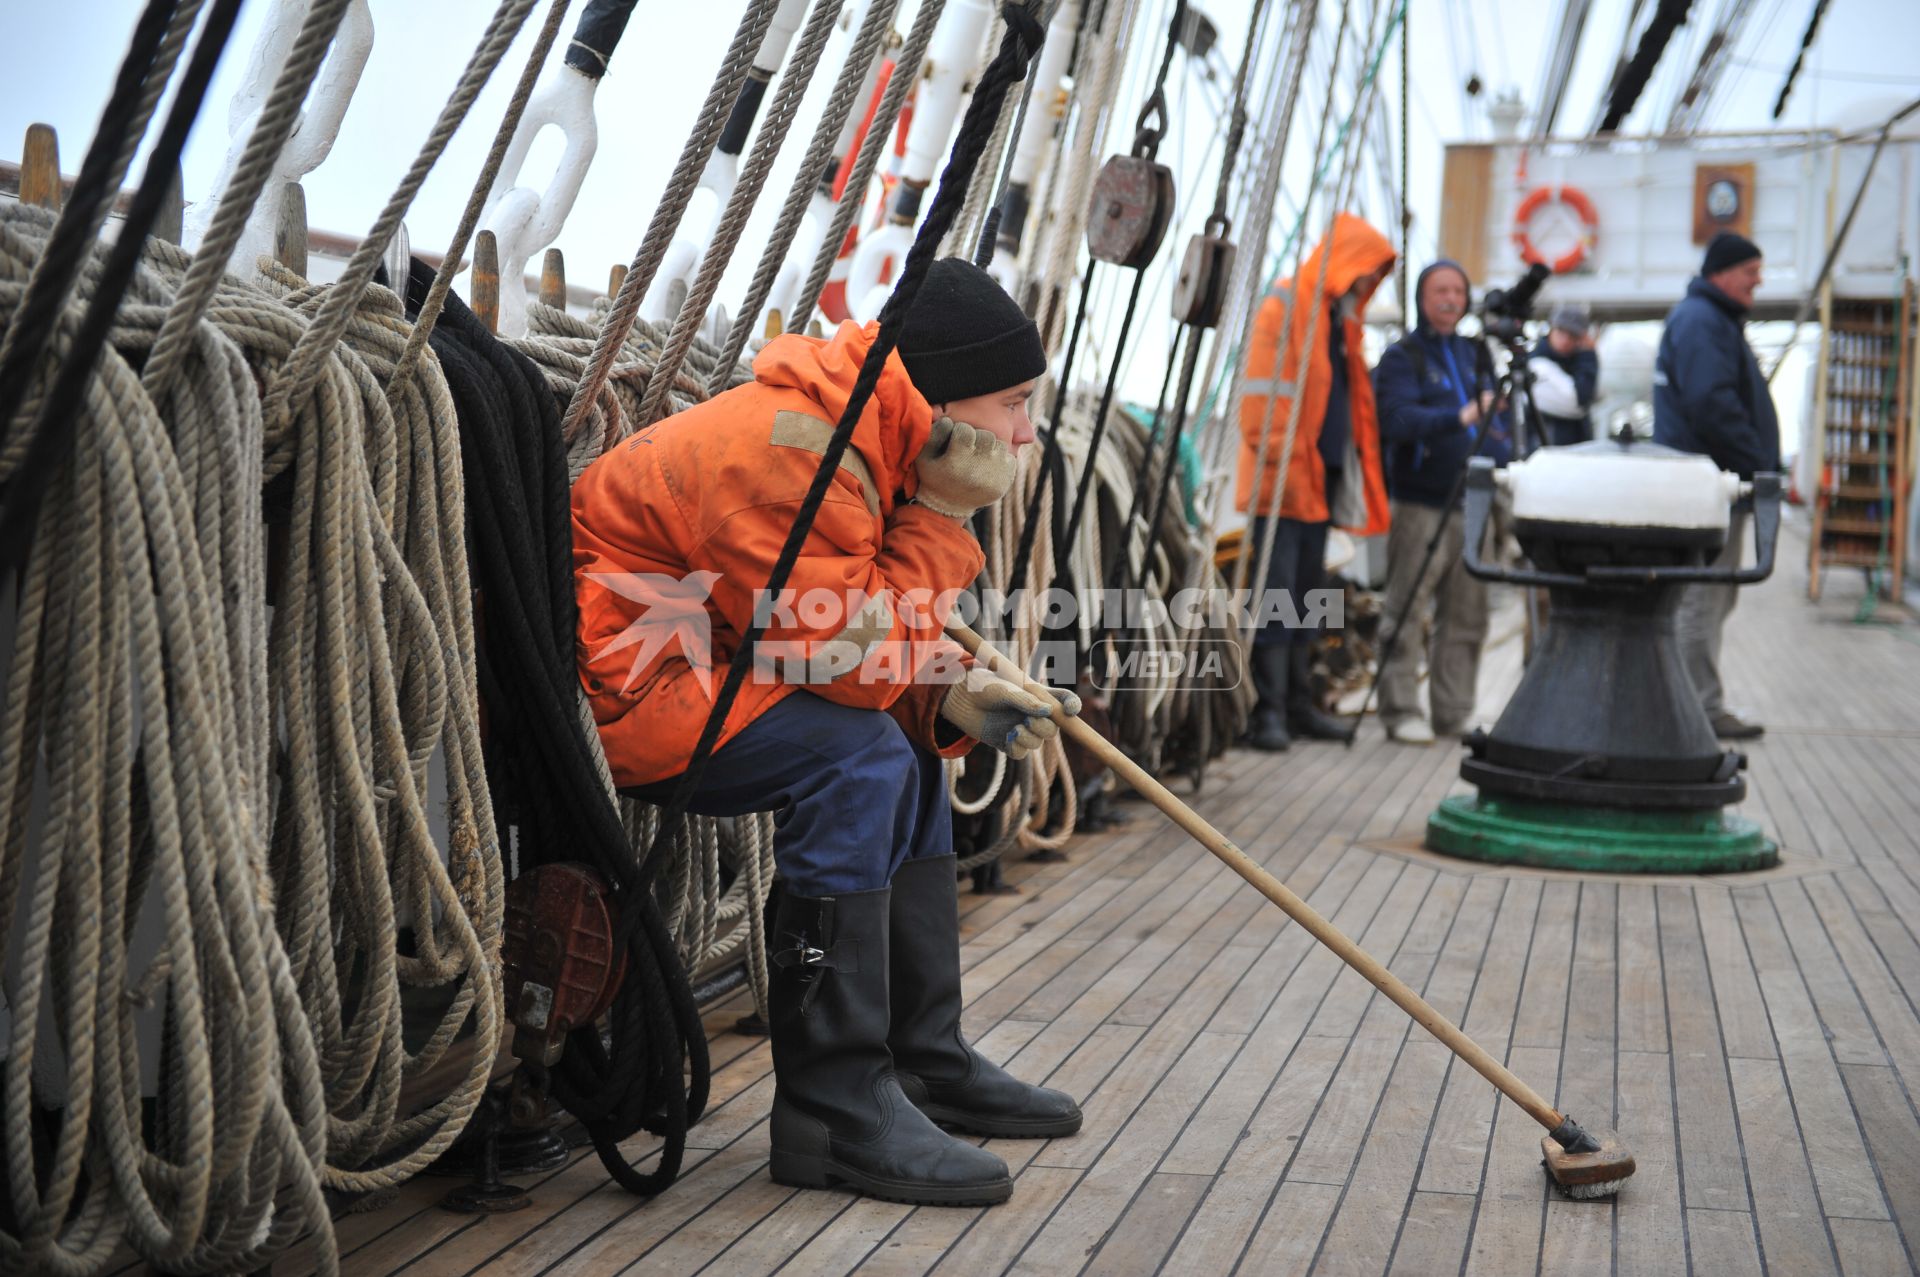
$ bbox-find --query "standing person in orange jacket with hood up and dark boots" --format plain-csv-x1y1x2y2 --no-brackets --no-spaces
1236,213,1398,749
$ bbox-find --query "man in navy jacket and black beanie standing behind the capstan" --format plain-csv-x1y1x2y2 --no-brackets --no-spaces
1653,230,1780,739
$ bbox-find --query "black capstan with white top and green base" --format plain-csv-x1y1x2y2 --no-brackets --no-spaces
1427,440,1780,874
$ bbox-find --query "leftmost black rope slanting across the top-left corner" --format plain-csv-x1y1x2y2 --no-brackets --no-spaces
0,0,180,442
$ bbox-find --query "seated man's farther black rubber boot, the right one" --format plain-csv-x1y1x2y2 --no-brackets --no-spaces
887,856,1081,1139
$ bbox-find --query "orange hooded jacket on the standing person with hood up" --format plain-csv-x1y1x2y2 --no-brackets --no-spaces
1235,213,1398,536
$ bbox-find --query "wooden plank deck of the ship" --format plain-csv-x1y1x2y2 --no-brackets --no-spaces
276,526,1920,1277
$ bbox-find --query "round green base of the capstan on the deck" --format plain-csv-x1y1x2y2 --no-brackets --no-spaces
1427,795,1780,874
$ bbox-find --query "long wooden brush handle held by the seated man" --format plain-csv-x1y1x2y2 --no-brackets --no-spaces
947,620,1565,1131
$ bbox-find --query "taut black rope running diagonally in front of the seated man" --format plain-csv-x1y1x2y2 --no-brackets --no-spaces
637,4,1043,926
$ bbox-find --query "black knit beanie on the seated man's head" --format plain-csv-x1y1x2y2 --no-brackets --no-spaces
899,257,1046,403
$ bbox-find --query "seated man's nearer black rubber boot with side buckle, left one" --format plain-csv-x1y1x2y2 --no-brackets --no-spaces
768,887,1014,1206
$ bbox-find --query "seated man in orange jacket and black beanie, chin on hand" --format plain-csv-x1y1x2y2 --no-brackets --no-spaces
572,257,1081,1206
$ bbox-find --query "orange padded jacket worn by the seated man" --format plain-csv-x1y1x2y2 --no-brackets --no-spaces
572,323,983,785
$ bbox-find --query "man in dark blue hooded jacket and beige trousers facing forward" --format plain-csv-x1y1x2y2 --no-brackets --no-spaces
1373,259,1513,745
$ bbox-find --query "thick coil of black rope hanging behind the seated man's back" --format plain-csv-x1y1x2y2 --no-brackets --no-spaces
407,266,710,1196
